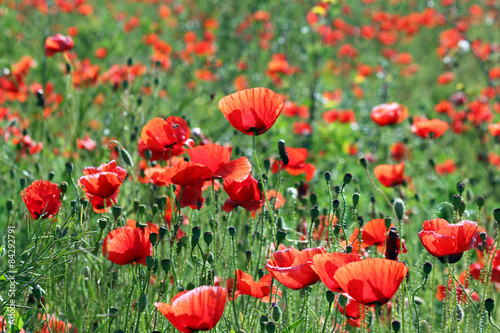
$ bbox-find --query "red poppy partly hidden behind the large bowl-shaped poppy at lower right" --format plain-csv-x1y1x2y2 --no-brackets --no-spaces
311,252,361,292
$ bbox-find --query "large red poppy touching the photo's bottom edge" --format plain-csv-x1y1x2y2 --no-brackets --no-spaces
155,286,227,333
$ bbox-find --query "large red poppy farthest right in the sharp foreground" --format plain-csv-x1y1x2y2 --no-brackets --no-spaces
418,219,477,264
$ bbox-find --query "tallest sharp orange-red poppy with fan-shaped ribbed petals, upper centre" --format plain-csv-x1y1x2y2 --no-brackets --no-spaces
219,88,283,135
